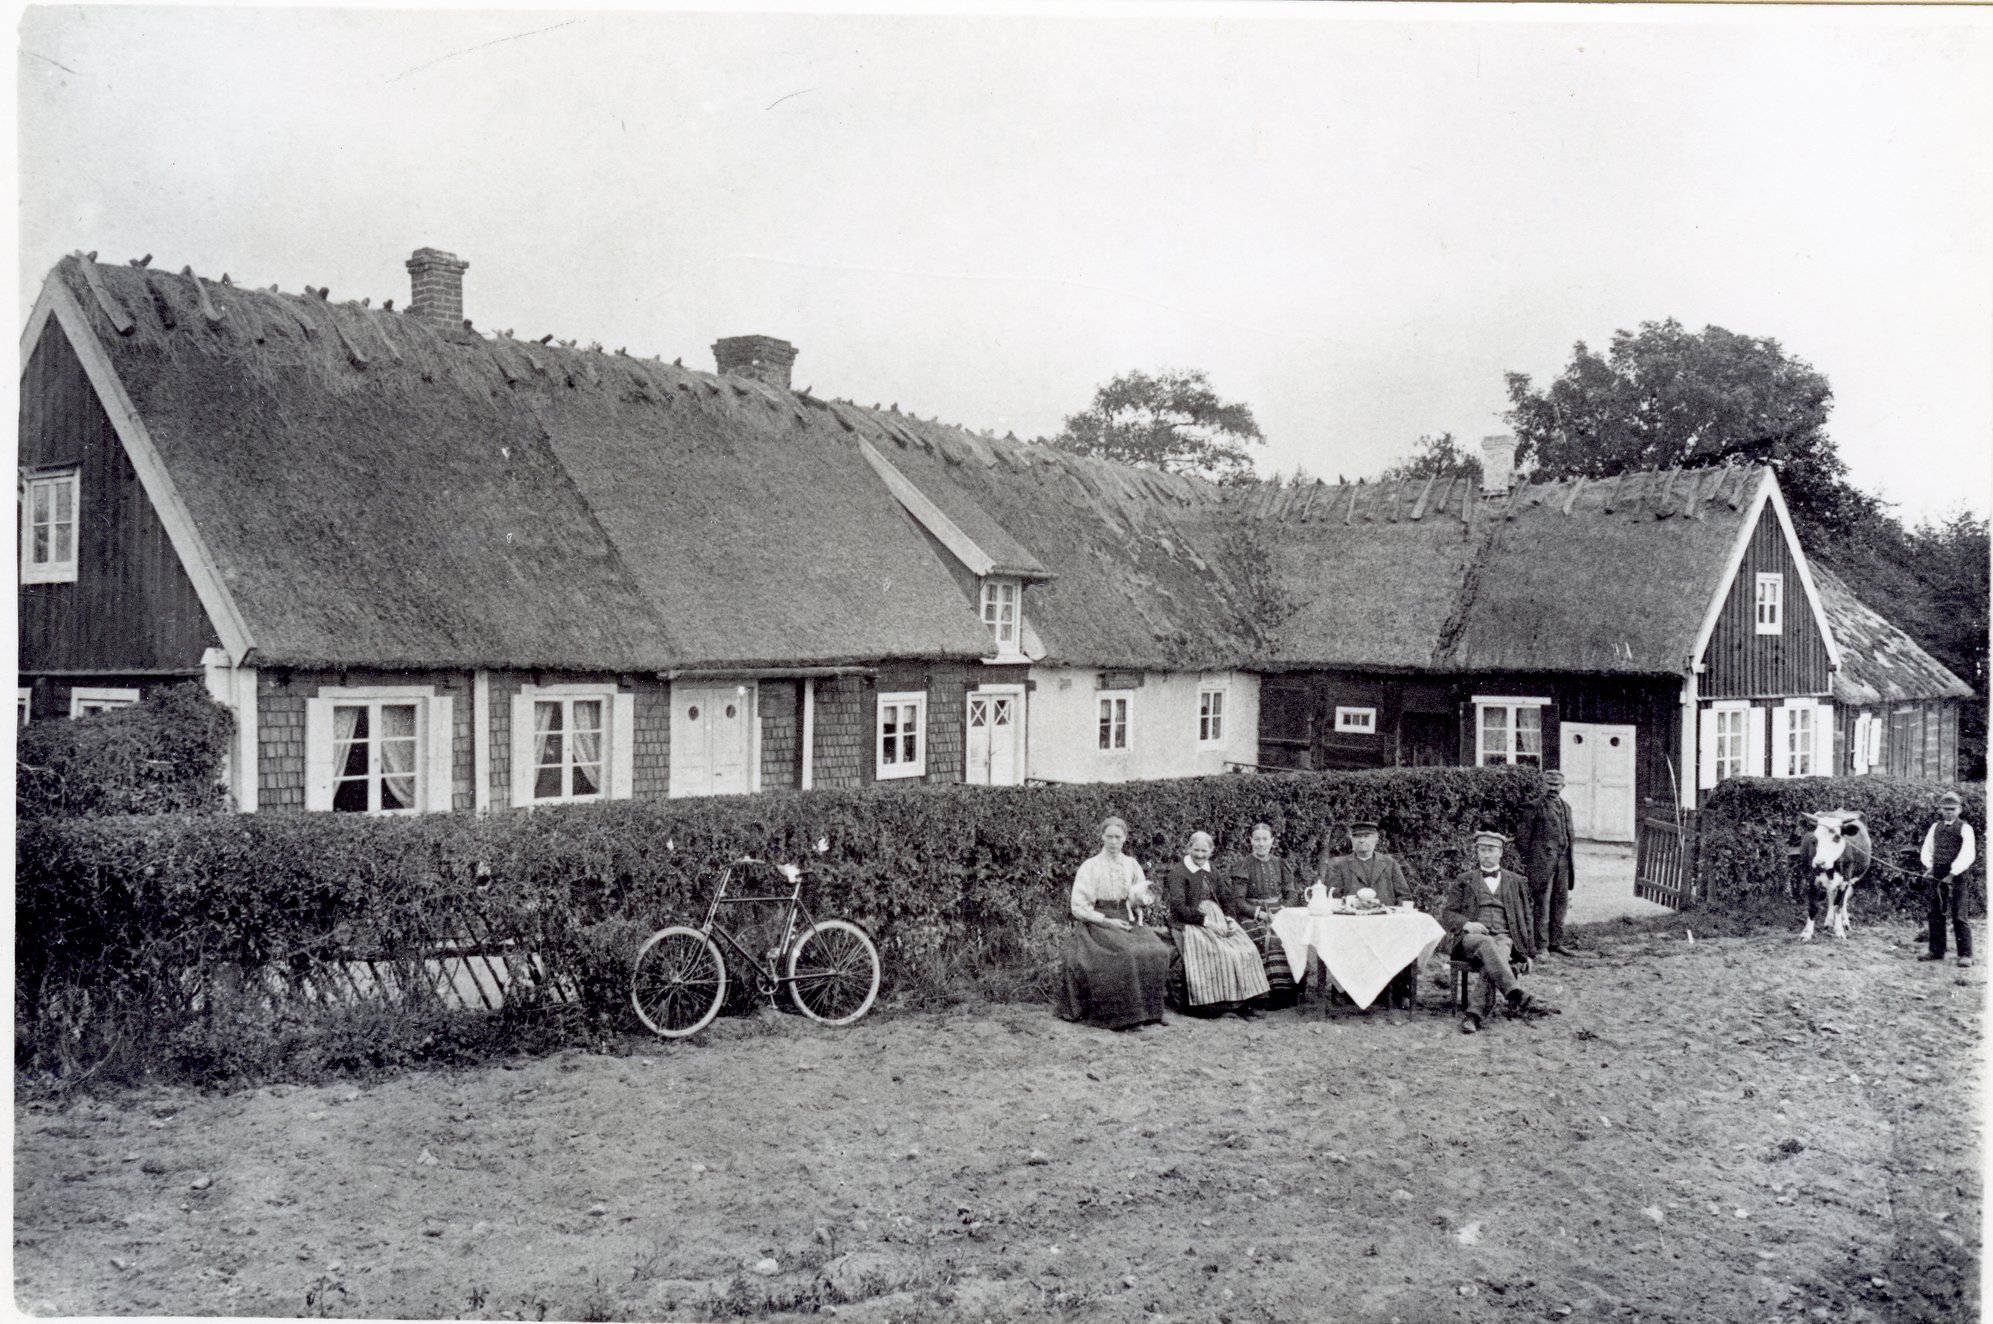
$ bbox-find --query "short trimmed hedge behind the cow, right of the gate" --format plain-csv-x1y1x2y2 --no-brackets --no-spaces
1696,776,1987,923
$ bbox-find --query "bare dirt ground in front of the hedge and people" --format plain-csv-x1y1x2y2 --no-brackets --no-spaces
14,923,1985,1324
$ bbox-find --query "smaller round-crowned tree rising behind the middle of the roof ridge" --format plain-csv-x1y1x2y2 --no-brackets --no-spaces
1050,369,1266,483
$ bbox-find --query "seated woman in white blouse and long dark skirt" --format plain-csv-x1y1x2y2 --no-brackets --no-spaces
1056,818,1170,1029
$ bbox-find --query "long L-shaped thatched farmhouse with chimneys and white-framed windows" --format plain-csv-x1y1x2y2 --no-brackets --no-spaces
18,249,1967,839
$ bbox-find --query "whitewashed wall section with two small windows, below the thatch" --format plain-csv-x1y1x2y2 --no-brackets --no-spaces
1024,666,1260,782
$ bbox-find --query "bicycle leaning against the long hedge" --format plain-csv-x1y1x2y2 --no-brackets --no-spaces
630,843,881,1039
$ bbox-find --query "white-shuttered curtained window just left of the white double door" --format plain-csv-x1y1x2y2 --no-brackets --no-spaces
512,682,636,808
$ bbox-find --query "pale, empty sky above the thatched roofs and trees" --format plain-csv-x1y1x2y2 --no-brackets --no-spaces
14,4,1993,522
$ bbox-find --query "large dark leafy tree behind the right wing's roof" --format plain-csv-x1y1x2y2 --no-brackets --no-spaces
1507,317,1879,526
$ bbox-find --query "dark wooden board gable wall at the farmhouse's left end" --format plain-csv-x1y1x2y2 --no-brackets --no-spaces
14,319,221,674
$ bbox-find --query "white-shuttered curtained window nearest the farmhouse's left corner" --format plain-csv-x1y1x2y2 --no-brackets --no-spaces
305,686,454,814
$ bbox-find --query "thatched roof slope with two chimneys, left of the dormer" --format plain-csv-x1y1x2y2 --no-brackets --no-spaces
54,257,991,670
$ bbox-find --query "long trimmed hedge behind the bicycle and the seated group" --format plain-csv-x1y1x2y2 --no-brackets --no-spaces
16,768,1543,1075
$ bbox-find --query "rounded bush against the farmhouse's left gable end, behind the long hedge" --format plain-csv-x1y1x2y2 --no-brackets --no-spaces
14,684,235,818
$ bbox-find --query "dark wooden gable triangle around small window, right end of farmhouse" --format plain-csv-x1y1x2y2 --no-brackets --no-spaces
1700,502,1828,698
